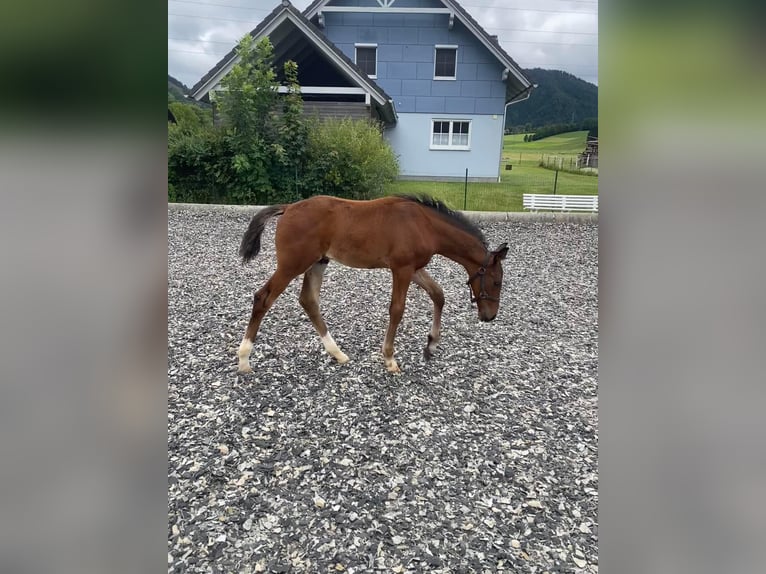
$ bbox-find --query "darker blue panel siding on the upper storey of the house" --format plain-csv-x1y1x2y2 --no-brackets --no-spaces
324,11,505,114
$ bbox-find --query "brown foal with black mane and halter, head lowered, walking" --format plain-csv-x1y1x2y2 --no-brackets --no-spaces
237,196,508,373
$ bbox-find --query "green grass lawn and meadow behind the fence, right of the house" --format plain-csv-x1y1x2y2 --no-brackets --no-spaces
386,131,598,211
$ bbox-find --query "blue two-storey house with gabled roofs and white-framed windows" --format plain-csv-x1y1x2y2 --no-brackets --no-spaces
191,0,534,181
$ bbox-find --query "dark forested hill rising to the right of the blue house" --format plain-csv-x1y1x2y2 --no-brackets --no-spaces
505,68,598,132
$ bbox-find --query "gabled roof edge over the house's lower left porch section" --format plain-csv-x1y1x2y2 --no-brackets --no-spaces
189,0,396,123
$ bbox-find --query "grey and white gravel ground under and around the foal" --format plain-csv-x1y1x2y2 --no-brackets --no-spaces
168,207,598,573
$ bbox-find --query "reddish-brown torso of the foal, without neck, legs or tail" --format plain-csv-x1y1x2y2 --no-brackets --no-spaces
276,195,434,269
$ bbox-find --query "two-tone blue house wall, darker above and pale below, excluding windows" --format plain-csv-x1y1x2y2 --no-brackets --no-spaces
324,0,506,179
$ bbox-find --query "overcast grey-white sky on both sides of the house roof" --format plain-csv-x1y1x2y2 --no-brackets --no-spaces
168,0,598,87
